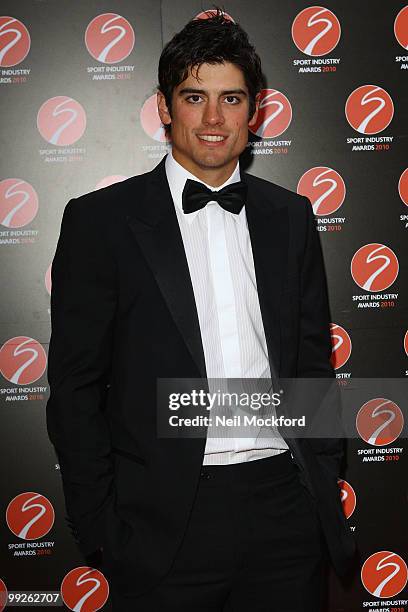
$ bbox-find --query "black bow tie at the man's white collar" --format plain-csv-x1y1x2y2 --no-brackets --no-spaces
182,179,248,215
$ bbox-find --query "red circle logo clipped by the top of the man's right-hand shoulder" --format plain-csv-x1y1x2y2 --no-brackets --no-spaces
297,166,346,216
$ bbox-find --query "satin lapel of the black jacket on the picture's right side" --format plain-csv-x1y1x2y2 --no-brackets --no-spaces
246,176,289,380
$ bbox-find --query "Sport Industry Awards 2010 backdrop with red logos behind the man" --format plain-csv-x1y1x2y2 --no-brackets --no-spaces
0,0,408,612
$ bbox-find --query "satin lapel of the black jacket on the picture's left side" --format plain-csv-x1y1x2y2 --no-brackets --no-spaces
127,160,206,378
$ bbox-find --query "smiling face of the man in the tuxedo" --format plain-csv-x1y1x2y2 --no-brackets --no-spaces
158,62,258,187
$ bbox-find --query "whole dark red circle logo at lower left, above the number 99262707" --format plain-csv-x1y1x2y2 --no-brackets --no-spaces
6,491,55,540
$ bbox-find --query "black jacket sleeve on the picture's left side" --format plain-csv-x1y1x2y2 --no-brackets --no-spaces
47,198,117,555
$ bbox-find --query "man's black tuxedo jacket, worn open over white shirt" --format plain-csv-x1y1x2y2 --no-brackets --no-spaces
47,155,354,593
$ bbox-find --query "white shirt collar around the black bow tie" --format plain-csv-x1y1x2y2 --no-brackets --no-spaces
166,151,245,223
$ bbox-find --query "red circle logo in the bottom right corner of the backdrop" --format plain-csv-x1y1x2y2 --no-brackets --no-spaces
361,550,408,599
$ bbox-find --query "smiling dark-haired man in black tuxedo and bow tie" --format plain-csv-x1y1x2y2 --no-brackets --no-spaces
47,11,353,612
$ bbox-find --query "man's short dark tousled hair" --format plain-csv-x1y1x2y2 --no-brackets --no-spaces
158,8,265,132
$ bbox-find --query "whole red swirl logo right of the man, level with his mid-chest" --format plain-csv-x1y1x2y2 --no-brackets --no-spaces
351,243,399,292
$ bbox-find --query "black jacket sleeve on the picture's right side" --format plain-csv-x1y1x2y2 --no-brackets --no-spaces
297,198,344,479
